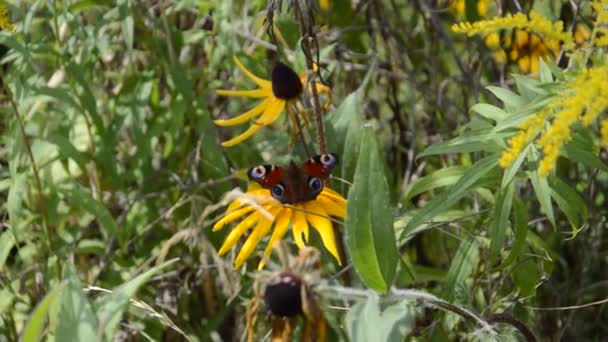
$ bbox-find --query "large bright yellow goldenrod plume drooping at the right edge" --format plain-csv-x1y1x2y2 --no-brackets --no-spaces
499,67,608,176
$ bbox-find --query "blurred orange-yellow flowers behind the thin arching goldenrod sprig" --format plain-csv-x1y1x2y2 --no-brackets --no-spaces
485,29,561,74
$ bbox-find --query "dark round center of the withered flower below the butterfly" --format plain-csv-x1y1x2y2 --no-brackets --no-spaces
264,272,302,317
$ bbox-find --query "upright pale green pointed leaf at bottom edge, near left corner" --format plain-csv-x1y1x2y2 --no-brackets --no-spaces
55,263,97,341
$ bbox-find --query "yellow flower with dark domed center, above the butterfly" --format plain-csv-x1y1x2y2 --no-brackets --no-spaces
215,57,331,147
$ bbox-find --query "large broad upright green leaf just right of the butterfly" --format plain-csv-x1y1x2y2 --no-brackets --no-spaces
345,127,398,292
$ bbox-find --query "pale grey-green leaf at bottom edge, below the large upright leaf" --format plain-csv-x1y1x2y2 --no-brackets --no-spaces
345,295,416,342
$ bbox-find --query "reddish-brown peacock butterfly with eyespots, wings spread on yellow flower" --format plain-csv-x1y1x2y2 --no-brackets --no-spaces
247,153,338,204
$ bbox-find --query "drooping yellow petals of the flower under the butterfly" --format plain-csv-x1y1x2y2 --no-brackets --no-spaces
213,186,346,269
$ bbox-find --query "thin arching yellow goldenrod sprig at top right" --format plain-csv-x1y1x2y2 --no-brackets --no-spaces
452,11,573,49
